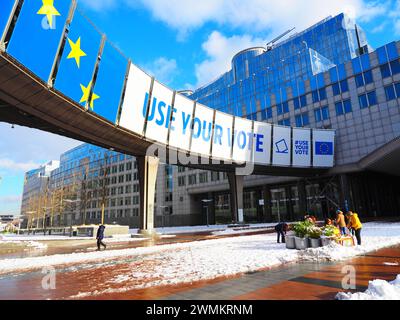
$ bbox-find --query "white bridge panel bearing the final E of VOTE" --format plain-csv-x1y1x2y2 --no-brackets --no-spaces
253,122,272,165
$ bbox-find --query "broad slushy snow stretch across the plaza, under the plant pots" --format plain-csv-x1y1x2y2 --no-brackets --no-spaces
0,223,400,297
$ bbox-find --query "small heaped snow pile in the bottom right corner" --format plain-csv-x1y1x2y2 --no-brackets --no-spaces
336,275,400,300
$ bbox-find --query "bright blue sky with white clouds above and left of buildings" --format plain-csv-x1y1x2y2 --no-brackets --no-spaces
0,0,400,214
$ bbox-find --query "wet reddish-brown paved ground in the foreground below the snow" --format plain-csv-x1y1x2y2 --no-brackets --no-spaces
0,246,400,300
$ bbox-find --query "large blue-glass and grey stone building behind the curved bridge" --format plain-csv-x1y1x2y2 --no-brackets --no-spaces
23,14,400,226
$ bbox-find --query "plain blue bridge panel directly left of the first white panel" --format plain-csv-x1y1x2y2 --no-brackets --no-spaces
90,42,128,123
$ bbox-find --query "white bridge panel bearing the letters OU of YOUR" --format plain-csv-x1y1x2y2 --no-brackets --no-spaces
190,103,215,156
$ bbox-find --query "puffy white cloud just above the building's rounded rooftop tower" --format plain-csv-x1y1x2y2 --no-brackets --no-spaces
195,31,265,87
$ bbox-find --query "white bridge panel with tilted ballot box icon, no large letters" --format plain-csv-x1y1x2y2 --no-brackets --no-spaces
272,126,291,166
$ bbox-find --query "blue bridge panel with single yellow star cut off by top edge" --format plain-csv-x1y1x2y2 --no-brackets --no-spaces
7,0,72,82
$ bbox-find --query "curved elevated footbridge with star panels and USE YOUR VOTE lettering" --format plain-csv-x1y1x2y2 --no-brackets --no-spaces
0,0,335,230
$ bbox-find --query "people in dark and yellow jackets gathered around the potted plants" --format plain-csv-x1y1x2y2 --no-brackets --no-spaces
275,210,362,246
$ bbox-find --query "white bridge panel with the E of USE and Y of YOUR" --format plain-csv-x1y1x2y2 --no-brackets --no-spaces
169,94,194,151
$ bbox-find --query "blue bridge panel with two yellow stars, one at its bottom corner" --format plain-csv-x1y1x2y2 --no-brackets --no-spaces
54,11,102,109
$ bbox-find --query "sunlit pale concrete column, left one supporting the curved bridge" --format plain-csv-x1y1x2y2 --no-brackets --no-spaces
136,156,160,235
